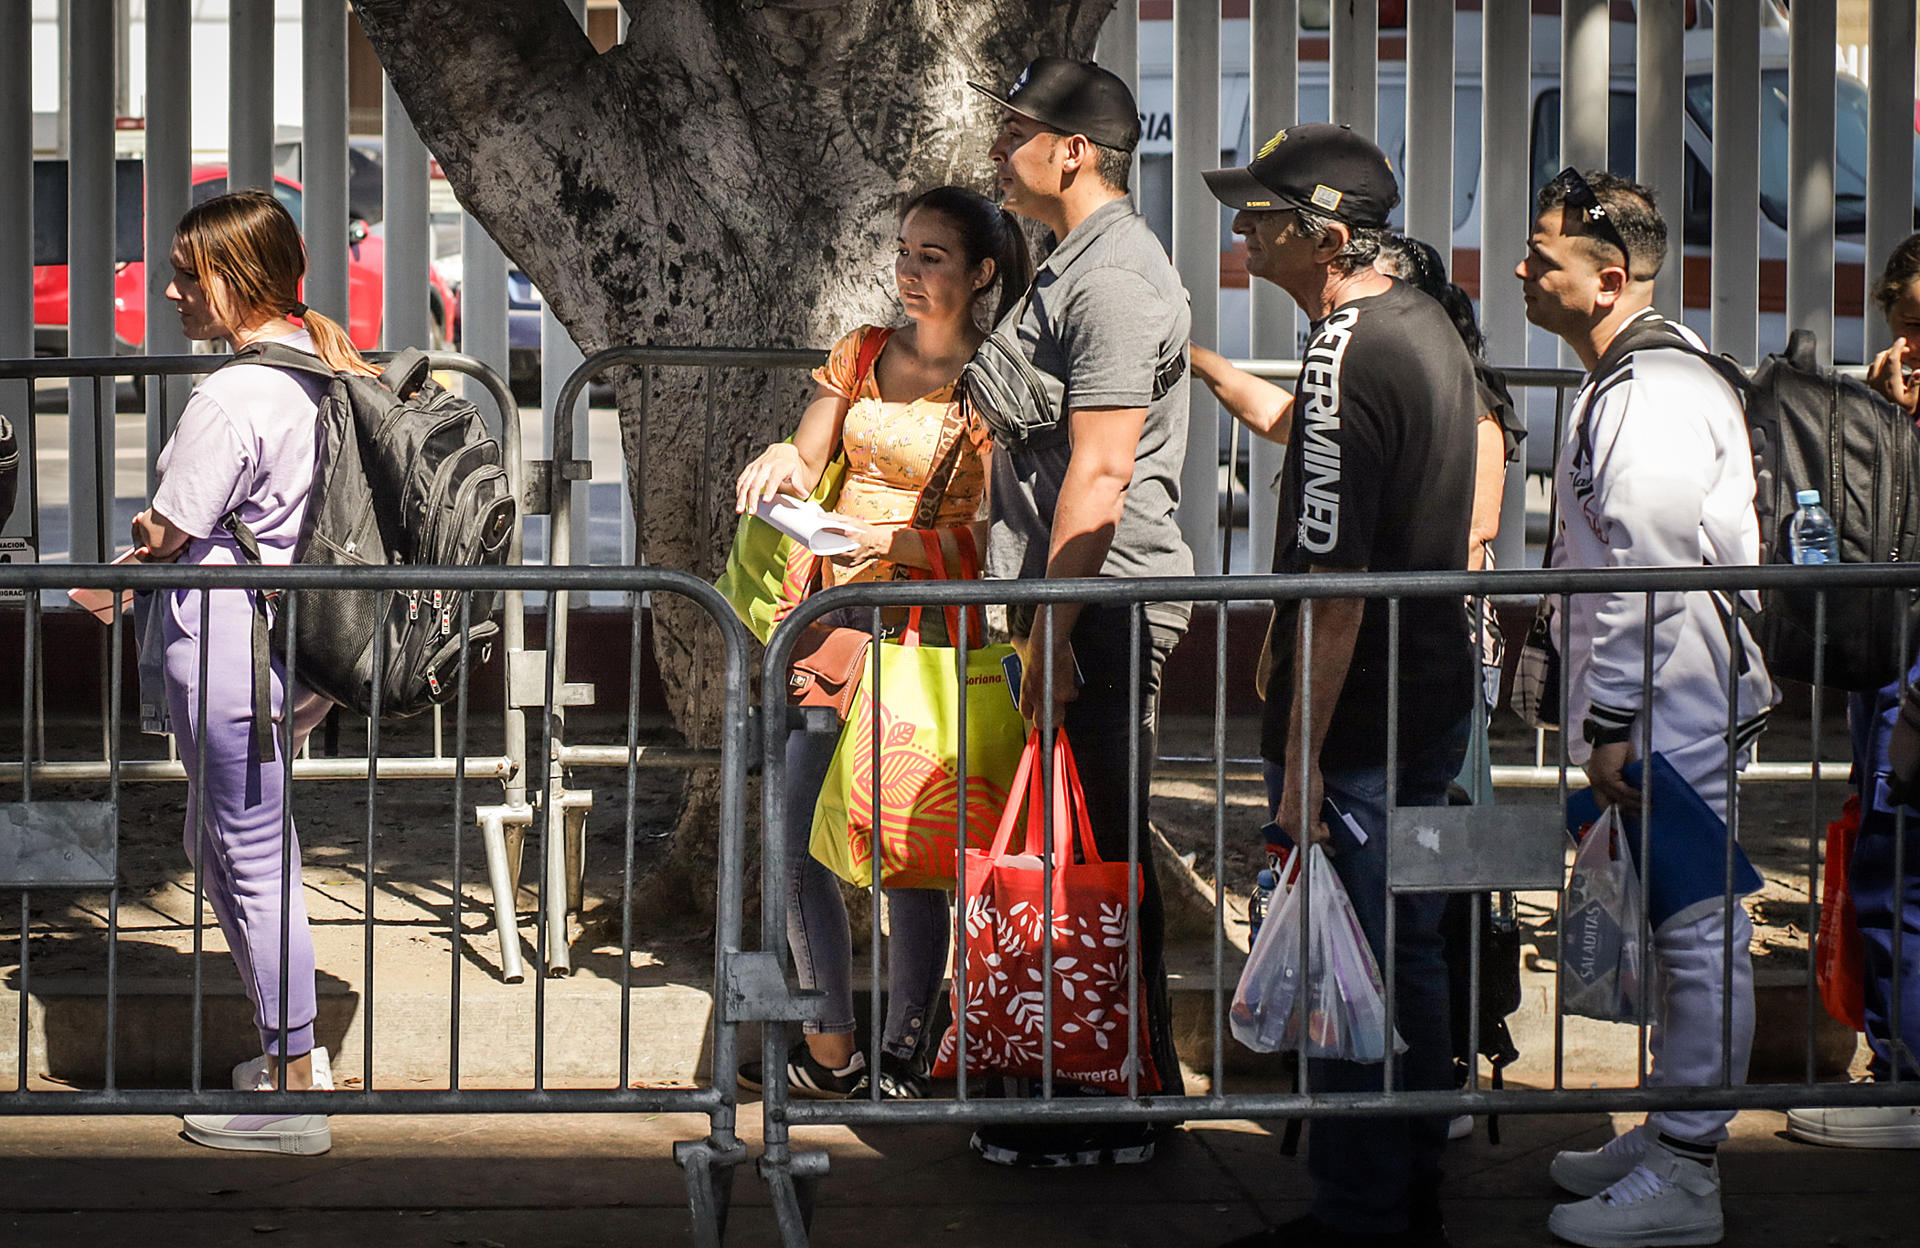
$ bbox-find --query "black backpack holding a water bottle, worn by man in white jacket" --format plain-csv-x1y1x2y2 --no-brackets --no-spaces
1594,323,1920,691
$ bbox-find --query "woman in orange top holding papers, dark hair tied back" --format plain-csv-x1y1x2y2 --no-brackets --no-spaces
735,186,1033,1100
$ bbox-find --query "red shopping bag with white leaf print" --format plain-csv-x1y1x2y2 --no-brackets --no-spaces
933,730,1160,1092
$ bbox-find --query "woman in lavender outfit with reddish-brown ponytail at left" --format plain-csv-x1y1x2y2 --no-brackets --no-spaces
132,190,357,1154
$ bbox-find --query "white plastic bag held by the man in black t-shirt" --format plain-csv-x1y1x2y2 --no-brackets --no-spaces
1231,845,1407,1062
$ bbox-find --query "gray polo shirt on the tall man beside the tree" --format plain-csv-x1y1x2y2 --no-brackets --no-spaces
987,198,1194,632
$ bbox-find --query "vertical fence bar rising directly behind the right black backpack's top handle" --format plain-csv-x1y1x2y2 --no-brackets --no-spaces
1781,4,1836,363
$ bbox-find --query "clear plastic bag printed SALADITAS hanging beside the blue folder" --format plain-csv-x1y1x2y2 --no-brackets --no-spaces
1561,806,1642,1023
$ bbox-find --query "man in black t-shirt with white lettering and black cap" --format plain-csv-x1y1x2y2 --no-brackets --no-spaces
1206,125,1482,1244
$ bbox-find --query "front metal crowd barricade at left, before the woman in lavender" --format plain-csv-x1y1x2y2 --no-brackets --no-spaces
0,564,749,1248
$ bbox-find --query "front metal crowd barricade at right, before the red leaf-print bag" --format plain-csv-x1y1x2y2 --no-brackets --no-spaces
748,564,1920,1248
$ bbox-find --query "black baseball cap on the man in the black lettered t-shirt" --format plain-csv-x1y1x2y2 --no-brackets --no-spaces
1202,123,1400,227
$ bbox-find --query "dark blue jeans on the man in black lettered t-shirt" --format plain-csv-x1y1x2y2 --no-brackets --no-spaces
1267,716,1469,1235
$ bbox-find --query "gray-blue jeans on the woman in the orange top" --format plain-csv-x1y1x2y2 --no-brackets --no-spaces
787,718,948,1062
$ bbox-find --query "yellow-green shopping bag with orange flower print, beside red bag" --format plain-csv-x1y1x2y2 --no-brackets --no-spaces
812,609,1027,889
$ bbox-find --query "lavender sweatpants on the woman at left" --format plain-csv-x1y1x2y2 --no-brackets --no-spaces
161,589,332,1058
